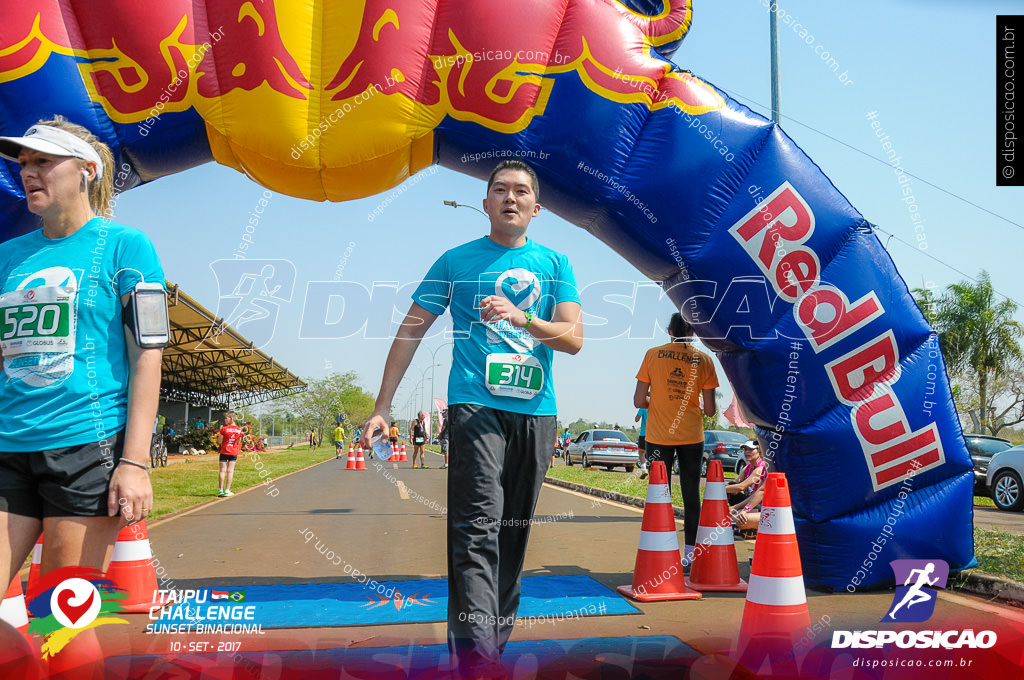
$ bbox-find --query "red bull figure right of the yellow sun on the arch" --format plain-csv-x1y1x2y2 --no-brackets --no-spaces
327,0,724,132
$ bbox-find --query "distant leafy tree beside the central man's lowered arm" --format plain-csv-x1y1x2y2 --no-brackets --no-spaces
288,371,374,438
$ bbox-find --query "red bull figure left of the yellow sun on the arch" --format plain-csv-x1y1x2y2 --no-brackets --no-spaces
0,0,311,122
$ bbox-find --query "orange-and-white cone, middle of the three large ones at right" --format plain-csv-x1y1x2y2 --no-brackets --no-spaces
686,461,746,593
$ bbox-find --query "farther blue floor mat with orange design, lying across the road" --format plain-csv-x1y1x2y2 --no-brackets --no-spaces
152,575,639,631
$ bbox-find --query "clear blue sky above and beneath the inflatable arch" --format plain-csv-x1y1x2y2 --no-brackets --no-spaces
116,0,1024,425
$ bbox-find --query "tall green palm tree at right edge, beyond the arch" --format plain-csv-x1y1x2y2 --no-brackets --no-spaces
933,270,1024,433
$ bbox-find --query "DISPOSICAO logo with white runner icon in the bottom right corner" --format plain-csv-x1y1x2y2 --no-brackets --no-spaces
831,559,996,649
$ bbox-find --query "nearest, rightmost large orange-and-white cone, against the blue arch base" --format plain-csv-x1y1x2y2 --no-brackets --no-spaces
739,472,811,656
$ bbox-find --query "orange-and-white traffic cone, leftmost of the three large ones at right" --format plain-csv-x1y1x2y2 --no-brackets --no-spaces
618,461,700,602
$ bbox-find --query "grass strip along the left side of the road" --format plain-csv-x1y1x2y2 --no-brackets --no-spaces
150,447,334,520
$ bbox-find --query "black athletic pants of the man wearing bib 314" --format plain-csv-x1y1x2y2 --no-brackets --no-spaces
447,403,556,677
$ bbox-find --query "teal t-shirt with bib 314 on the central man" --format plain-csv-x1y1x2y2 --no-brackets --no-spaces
413,237,580,416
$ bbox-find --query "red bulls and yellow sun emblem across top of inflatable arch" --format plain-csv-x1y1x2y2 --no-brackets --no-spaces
0,0,724,201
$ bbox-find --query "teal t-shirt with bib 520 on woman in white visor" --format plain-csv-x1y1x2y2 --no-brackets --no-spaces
0,218,164,452
